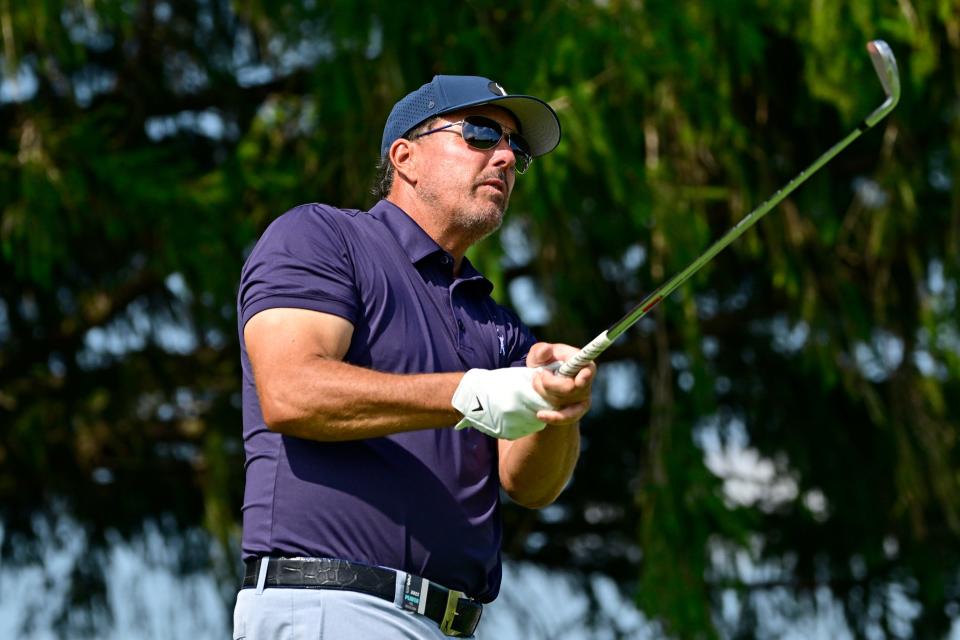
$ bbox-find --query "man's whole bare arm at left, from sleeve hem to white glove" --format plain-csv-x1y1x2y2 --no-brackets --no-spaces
243,308,463,441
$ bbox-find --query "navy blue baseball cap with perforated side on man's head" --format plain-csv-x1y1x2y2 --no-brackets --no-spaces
380,76,560,157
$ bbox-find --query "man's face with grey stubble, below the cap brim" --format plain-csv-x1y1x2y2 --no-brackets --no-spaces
415,105,518,244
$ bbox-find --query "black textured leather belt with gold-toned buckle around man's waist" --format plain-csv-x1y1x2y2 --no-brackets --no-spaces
241,558,483,636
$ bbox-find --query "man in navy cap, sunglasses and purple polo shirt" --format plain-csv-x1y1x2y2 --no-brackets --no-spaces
234,76,595,639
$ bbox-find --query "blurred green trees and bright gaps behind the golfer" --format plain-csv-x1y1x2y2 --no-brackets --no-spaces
0,0,960,639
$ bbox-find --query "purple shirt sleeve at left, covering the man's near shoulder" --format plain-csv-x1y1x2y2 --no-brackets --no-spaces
237,204,359,331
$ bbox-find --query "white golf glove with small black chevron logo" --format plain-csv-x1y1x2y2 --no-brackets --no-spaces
453,367,554,440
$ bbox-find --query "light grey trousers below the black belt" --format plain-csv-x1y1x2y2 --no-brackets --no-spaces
233,588,472,640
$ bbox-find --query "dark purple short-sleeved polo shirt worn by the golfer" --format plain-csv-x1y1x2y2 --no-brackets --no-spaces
238,200,535,601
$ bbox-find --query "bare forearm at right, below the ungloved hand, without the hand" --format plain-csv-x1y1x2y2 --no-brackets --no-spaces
499,423,580,509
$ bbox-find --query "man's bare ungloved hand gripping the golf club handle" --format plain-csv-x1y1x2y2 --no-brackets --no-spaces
527,342,597,425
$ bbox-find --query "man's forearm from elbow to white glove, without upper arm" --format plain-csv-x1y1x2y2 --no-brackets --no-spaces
257,357,463,441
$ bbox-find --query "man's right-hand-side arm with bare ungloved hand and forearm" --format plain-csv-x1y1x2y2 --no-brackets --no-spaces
498,342,597,509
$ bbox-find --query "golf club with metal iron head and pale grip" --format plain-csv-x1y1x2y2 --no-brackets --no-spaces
558,40,900,377
